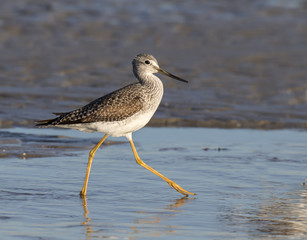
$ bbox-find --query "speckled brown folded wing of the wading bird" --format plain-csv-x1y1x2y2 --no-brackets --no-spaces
38,83,144,126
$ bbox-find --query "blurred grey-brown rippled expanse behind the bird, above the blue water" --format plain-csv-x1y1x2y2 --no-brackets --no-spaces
0,0,307,128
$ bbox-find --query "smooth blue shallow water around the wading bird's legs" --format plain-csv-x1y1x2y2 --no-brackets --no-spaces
0,128,307,240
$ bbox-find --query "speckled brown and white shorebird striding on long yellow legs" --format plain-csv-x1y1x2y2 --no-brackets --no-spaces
37,54,195,196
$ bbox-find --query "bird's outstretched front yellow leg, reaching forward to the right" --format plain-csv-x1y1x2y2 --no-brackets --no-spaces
129,139,195,196
